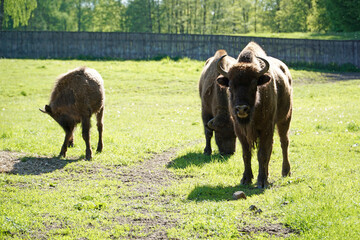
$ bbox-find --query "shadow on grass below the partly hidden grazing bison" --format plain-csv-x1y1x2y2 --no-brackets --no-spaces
166,152,231,169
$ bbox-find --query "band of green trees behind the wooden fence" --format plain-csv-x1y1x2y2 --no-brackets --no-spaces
0,0,360,34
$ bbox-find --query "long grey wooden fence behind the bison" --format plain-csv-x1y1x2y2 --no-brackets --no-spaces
0,31,360,68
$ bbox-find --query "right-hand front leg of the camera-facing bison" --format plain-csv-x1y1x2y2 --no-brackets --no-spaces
257,129,274,188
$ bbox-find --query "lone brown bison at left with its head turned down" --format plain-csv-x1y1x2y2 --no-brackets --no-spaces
40,67,105,160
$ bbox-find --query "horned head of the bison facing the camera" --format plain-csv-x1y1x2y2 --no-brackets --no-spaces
217,55,271,124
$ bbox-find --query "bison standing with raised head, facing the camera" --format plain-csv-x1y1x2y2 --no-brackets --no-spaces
217,42,292,188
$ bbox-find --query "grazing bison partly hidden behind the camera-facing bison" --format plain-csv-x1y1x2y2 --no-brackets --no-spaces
199,50,236,155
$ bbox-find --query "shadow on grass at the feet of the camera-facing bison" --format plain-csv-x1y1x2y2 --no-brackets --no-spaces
187,185,265,202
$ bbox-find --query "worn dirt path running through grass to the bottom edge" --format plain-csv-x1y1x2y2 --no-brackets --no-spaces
117,149,179,239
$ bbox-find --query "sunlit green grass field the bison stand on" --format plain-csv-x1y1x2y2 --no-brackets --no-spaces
0,59,360,239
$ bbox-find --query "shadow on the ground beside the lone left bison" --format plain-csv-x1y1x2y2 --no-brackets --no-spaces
9,157,83,175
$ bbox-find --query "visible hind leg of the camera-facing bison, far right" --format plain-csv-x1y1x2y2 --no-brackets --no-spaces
277,119,291,177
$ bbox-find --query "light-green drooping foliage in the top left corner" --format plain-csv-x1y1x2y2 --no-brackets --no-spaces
0,0,37,30
